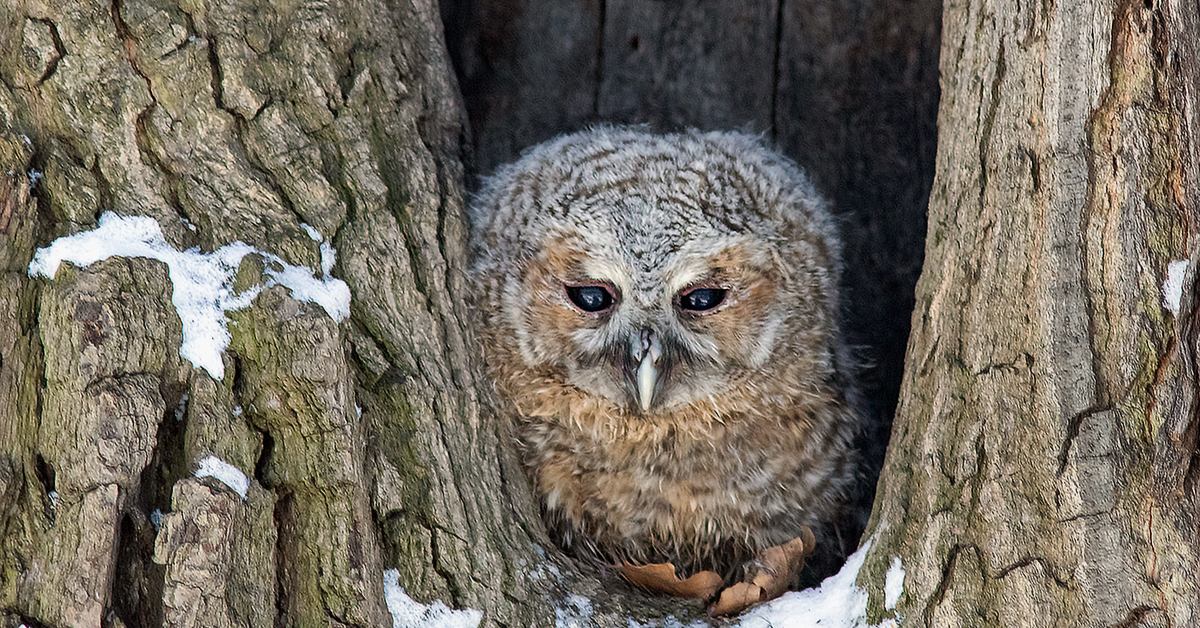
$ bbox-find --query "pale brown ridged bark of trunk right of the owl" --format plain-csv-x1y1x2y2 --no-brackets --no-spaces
862,0,1200,627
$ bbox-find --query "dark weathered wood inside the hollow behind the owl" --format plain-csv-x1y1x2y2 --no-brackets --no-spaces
443,0,941,569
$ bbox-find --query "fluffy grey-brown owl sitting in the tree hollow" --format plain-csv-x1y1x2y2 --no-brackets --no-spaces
470,126,859,590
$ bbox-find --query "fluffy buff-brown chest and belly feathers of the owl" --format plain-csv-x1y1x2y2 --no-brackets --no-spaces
521,377,848,567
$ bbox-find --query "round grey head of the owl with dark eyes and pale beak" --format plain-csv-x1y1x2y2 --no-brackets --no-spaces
472,127,840,418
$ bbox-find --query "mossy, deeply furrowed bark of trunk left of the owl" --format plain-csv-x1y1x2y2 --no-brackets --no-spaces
0,0,623,627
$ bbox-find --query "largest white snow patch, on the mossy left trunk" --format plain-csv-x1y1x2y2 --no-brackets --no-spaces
29,211,350,379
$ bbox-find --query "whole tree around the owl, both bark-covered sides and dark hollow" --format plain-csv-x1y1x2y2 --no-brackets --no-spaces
18,0,1200,627
